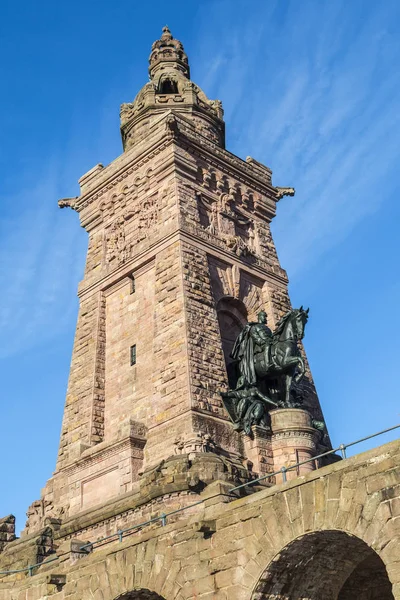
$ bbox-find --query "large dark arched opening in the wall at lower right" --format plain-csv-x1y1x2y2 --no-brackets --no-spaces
252,531,394,600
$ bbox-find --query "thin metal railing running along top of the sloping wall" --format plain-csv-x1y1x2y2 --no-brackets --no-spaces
0,424,400,576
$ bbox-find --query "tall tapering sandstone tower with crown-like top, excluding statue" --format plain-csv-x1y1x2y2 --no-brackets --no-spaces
21,27,329,532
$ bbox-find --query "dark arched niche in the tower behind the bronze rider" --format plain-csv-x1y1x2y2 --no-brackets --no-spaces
217,297,247,389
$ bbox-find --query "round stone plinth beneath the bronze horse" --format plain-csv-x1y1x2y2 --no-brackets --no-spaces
269,408,319,483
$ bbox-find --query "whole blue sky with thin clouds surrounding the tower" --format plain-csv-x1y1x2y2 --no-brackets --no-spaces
0,0,400,528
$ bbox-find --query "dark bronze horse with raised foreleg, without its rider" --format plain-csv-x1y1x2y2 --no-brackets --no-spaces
254,306,310,406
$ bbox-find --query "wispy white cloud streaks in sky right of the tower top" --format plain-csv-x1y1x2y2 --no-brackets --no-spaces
192,0,400,277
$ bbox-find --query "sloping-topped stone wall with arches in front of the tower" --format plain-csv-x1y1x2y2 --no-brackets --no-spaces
0,441,400,600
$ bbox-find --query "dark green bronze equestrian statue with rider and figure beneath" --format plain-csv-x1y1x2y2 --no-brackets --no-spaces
221,306,309,435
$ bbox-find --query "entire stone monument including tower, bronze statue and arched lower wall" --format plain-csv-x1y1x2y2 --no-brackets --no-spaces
9,27,400,600
